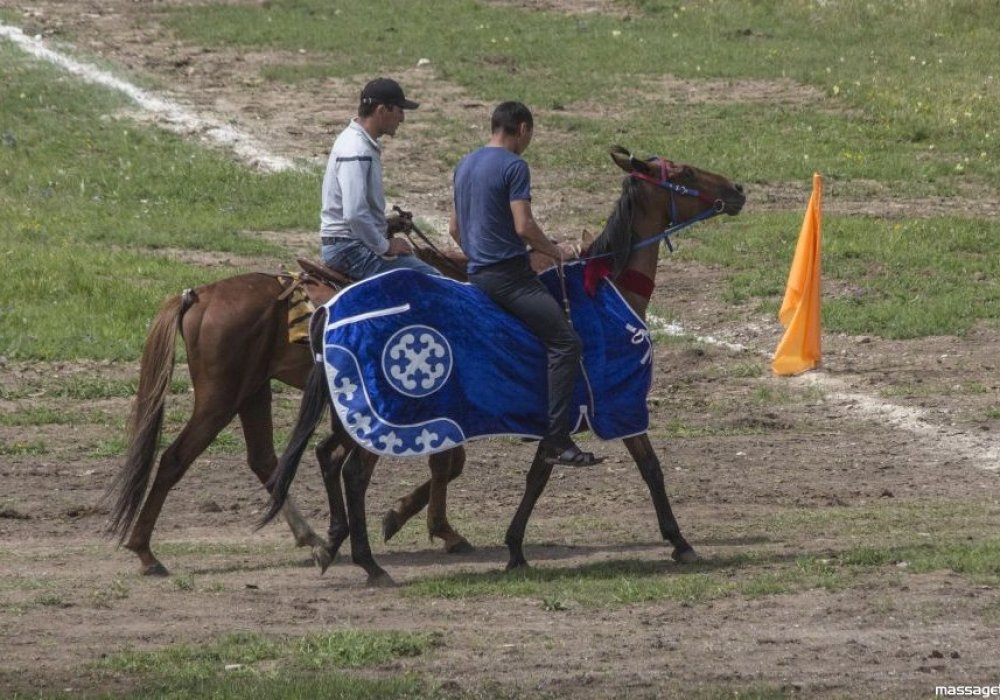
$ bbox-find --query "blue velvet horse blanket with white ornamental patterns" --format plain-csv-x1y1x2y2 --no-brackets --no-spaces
316,263,653,457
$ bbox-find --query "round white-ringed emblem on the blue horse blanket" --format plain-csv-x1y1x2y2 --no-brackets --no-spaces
382,326,452,397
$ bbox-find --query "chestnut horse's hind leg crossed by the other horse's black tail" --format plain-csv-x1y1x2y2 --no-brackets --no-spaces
239,383,326,559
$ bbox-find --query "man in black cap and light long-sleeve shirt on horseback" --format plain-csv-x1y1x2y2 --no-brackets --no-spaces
320,78,440,279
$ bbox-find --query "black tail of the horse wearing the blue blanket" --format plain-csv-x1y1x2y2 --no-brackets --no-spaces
257,308,330,529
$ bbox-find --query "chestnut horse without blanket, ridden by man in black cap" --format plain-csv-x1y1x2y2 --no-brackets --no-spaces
107,247,472,576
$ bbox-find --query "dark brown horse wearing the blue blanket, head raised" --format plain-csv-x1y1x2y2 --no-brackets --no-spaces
265,147,746,585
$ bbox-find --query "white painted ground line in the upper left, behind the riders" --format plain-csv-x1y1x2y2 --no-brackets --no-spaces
0,22,299,172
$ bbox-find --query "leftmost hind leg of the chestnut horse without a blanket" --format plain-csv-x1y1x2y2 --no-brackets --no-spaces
125,406,233,576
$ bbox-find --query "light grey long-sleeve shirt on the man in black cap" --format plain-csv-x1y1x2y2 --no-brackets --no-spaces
320,120,389,255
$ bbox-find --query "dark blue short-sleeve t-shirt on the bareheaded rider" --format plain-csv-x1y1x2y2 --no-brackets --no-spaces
454,146,531,273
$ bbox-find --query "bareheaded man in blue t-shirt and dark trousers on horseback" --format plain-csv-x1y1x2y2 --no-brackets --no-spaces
449,102,602,466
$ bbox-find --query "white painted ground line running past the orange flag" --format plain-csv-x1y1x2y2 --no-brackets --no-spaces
647,314,1000,471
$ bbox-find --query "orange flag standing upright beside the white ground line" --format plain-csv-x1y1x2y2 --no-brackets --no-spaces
771,173,823,376
